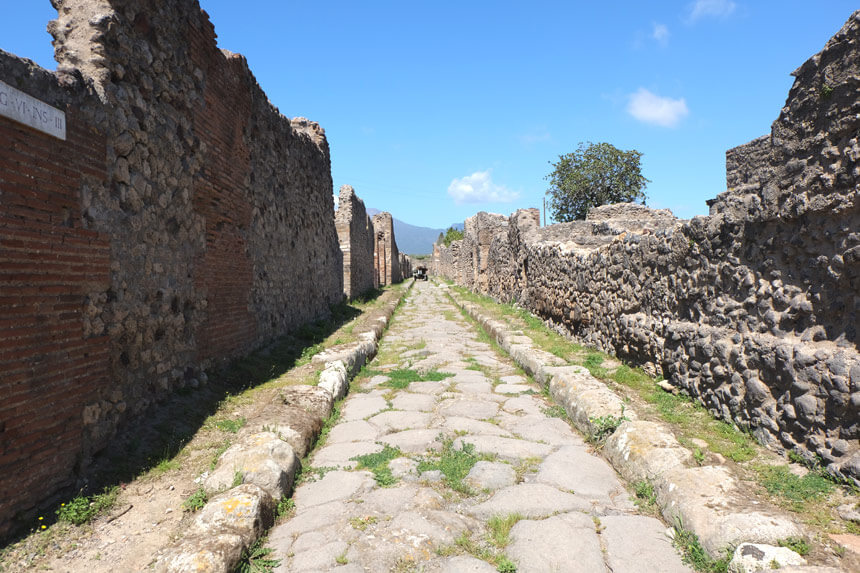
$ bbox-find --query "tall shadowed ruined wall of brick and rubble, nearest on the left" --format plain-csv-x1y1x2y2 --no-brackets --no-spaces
0,0,343,533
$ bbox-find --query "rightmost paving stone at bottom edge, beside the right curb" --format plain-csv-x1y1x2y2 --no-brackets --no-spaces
600,515,693,573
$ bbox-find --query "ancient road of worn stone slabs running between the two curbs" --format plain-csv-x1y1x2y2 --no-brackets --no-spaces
268,282,689,573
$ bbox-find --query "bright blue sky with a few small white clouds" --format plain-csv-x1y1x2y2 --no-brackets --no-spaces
0,0,857,227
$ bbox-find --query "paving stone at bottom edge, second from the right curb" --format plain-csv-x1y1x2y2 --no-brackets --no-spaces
506,513,608,573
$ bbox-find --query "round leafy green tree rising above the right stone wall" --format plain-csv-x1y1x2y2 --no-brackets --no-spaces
545,142,649,223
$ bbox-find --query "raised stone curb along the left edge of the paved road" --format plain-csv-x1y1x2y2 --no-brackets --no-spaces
155,280,415,573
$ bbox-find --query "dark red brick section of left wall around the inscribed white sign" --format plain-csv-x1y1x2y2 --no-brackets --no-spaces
0,53,110,533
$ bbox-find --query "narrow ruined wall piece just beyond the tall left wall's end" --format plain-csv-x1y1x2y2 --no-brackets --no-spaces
334,185,379,298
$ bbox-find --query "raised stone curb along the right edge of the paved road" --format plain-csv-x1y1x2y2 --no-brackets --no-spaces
441,285,804,558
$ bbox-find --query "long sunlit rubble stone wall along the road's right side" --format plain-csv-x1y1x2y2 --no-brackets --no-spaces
433,12,860,480
